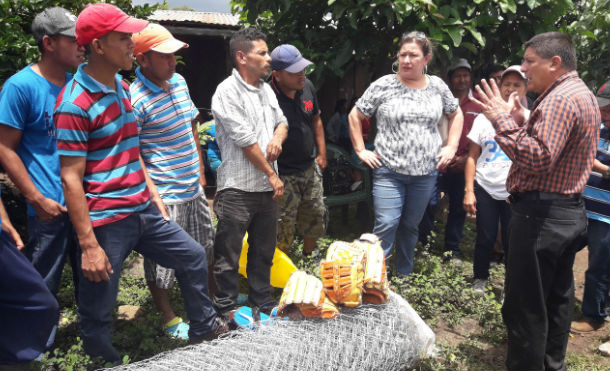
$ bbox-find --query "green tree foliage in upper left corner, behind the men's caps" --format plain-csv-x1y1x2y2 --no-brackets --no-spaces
0,0,159,84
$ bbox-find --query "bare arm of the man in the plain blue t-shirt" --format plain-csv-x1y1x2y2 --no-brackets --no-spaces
0,124,67,221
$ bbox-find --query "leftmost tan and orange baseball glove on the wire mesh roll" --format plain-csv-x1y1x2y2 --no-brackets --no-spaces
278,271,339,318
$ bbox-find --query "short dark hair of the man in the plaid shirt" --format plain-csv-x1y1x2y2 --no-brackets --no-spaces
525,32,576,71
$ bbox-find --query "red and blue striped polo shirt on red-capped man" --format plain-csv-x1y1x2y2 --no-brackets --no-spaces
53,64,150,227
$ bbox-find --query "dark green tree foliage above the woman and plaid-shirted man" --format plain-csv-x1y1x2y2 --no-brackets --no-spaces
233,0,610,89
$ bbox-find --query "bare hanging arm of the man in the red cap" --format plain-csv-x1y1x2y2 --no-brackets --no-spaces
59,156,114,282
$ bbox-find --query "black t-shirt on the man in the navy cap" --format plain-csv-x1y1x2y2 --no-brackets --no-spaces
271,80,320,175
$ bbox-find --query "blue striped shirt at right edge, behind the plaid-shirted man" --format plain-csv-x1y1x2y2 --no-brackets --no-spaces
583,125,610,224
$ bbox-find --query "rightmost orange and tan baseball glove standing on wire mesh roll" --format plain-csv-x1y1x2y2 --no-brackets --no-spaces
354,233,390,304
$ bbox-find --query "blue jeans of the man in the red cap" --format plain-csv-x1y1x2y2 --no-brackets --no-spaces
78,204,218,362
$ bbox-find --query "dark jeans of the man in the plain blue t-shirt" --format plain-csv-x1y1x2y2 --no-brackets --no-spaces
24,213,78,295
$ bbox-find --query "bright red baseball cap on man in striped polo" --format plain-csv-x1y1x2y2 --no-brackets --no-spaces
75,3,148,46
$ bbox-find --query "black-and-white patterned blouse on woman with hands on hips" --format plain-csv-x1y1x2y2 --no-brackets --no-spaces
356,75,458,175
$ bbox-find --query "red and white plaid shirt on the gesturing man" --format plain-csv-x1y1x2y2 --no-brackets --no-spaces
492,71,601,194
